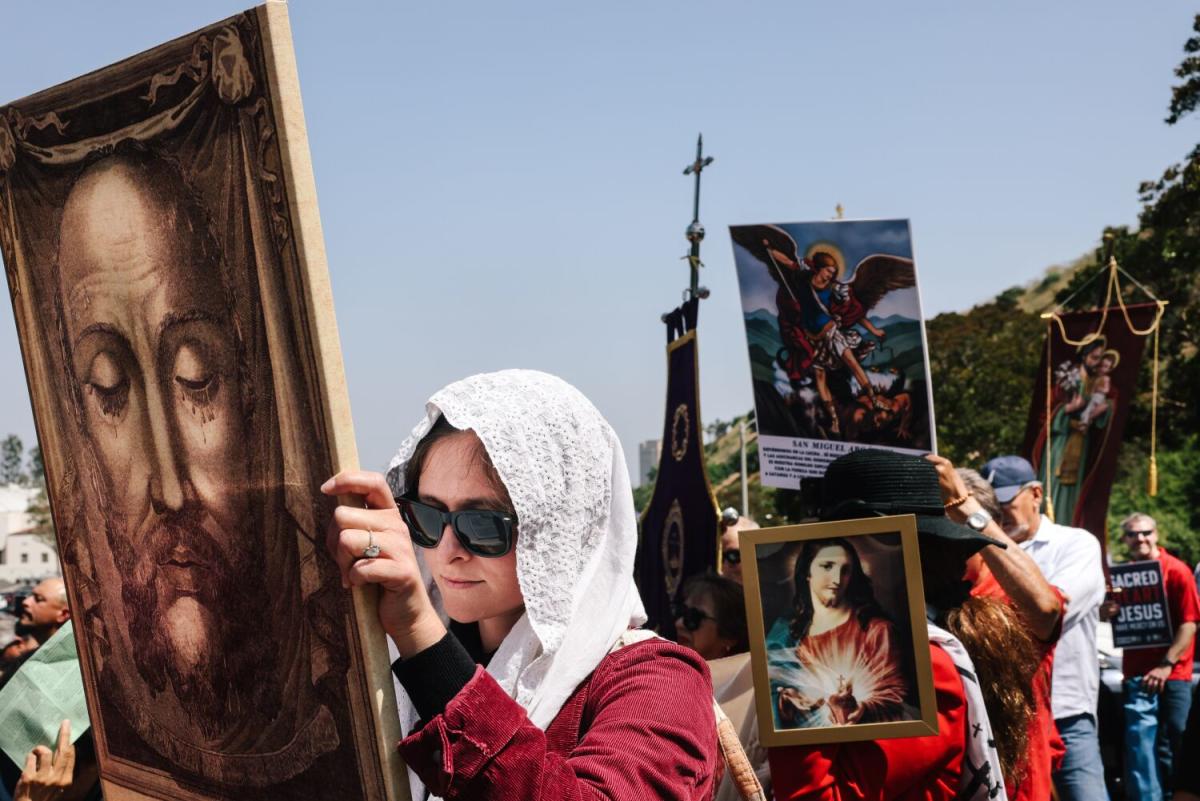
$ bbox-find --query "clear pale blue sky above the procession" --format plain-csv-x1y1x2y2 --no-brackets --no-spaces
0,0,1200,482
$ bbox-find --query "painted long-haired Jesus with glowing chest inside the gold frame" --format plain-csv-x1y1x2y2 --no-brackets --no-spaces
767,538,919,728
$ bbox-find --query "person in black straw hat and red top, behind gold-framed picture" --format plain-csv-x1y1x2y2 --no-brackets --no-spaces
770,448,1037,801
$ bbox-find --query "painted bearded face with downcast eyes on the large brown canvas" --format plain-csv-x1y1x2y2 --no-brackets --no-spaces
58,157,283,740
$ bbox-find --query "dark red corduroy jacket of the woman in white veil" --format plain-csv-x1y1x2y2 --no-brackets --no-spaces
400,639,721,801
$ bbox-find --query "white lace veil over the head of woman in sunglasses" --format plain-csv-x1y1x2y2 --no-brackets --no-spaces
388,369,646,799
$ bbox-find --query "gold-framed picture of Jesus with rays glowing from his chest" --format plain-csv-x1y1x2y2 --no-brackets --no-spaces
739,514,937,747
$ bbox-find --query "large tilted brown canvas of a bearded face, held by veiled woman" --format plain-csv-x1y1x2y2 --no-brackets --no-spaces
0,2,407,801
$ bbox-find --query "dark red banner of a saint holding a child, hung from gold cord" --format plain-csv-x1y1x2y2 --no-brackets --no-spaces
1024,303,1159,548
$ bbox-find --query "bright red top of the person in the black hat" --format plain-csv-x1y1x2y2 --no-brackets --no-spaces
767,643,967,801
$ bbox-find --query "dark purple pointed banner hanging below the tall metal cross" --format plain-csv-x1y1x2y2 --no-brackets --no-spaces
637,297,720,639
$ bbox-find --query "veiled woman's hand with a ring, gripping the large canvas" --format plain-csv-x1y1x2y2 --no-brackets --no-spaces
320,470,446,658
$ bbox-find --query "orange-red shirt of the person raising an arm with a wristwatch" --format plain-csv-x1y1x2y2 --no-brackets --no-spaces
971,566,1067,801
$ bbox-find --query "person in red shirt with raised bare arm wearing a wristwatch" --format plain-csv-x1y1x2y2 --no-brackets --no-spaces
940,456,1067,801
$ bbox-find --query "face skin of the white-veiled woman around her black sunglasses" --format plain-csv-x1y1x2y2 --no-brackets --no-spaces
416,432,524,650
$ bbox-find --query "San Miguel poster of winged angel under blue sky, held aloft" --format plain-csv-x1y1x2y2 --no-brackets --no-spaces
730,219,935,489
